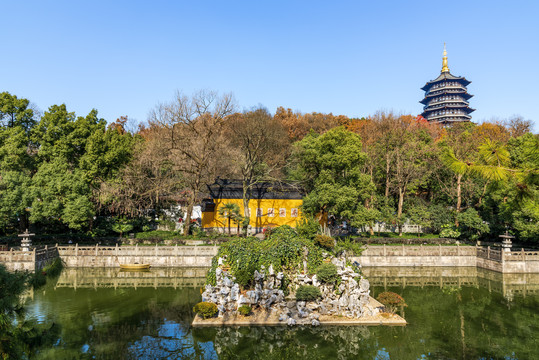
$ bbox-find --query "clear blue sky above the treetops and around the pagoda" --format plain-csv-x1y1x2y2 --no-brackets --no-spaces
0,0,539,132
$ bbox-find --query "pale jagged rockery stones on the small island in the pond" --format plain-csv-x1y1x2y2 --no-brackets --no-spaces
202,258,379,326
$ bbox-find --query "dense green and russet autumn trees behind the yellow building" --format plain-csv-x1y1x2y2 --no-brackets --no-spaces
0,91,539,243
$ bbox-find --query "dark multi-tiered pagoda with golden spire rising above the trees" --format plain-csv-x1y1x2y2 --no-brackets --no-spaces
420,44,475,125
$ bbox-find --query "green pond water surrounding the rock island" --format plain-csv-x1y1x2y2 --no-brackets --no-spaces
26,268,539,359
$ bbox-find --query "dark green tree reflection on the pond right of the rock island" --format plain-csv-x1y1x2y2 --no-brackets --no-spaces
373,287,539,359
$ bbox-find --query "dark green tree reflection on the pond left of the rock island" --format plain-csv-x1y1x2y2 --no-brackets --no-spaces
32,288,205,359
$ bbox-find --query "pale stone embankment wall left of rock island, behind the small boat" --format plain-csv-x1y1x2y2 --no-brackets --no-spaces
58,245,218,267
